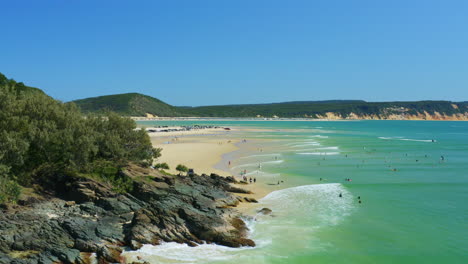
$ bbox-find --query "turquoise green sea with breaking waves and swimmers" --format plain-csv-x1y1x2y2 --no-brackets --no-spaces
127,120,468,263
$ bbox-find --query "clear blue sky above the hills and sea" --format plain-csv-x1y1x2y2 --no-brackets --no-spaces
0,0,468,105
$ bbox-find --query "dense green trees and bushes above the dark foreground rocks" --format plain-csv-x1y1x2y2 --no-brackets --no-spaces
0,74,161,203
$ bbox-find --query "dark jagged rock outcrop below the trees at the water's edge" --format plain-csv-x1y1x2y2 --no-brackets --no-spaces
0,167,255,264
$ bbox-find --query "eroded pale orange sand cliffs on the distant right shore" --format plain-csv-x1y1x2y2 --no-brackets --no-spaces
317,111,468,121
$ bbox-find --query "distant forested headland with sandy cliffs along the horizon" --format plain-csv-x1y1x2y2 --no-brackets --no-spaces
74,91,468,119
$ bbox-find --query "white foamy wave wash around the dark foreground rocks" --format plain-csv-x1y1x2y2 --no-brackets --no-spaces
123,183,354,264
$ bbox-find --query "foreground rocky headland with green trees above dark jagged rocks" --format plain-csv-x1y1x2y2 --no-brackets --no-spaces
0,72,255,264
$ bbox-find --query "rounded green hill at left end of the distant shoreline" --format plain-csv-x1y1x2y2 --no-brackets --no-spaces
73,93,185,116
